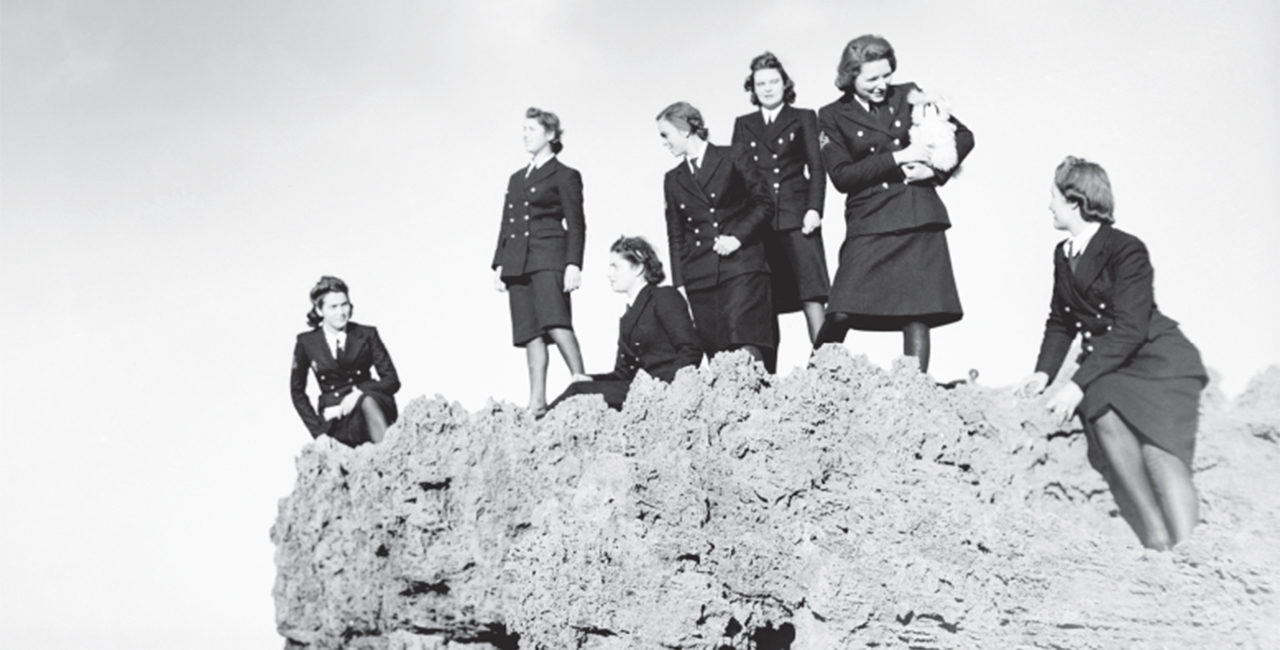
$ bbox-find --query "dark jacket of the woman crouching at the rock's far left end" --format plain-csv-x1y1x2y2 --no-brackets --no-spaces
289,322,399,438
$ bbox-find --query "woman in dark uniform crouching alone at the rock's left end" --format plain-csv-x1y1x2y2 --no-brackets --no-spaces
289,275,399,447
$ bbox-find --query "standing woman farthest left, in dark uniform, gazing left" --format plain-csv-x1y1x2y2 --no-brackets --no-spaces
492,109,586,415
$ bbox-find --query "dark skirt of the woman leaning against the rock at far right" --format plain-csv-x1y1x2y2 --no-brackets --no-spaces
1079,370,1206,471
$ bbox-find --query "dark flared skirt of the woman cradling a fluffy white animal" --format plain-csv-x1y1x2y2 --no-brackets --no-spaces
827,229,964,331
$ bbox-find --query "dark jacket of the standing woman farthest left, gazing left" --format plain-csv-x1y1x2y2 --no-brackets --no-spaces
490,157,586,278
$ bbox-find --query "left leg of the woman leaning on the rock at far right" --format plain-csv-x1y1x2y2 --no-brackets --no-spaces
1093,409,1170,550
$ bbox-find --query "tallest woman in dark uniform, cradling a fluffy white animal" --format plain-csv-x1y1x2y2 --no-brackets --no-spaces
815,35,973,371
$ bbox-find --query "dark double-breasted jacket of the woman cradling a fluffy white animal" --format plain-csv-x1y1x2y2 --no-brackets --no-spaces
818,83,973,237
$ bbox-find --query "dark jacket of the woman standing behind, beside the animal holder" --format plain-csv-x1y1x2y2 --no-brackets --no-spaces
733,105,827,230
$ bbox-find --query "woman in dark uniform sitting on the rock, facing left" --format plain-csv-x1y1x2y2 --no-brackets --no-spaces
552,237,703,409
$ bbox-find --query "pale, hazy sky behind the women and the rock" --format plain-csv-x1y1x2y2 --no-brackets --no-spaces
0,0,1280,650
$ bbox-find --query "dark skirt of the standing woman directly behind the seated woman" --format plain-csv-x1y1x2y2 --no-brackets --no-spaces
689,273,777,356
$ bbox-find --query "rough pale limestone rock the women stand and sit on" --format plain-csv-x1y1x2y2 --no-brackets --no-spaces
271,347,1280,650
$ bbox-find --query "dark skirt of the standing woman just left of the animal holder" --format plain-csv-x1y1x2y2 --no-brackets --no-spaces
764,229,831,313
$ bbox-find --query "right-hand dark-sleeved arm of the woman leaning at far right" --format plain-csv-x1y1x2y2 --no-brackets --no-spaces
1071,240,1156,388
